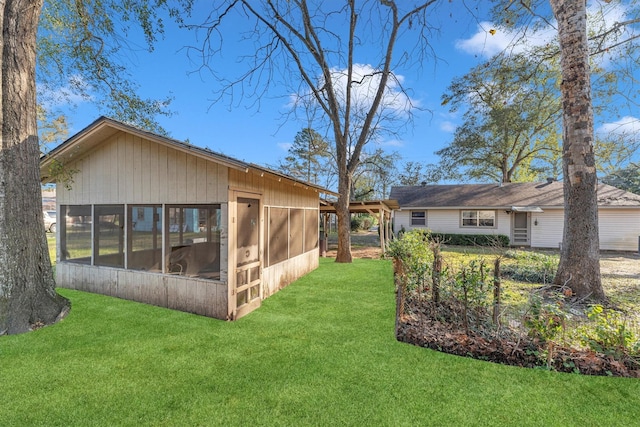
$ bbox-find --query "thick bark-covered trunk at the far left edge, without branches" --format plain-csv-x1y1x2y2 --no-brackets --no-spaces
0,0,69,335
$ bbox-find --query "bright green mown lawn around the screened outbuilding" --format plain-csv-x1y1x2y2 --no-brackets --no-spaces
0,259,640,426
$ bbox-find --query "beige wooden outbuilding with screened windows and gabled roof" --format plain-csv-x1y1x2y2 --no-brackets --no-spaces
40,117,333,319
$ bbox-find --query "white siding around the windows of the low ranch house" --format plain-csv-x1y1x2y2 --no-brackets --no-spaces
394,209,511,236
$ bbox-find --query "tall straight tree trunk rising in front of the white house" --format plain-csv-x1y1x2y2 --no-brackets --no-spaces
551,0,605,300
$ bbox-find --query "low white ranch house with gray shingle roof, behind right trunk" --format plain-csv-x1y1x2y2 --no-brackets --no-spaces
390,180,640,251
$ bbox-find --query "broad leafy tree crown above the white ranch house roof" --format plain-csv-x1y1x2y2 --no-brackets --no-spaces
436,53,560,182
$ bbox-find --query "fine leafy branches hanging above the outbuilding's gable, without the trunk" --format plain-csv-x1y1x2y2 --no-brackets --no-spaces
36,0,180,134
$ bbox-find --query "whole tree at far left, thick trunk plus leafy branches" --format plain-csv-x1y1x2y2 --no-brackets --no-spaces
0,0,190,335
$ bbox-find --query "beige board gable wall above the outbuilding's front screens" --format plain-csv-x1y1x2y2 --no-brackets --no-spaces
57,132,229,205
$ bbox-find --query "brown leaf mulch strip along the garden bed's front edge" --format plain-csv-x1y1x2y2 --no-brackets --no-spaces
396,300,640,378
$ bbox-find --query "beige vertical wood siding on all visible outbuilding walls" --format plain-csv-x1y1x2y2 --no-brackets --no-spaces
56,132,319,319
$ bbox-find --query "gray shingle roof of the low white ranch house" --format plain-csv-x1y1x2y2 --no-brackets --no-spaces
389,181,640,208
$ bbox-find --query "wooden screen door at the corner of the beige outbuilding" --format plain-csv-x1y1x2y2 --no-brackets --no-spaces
231,193,262,319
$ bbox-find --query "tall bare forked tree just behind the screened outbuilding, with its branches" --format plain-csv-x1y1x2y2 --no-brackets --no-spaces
190,0,436,262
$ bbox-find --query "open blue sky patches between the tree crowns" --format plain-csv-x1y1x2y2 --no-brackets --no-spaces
52,2,640,176
